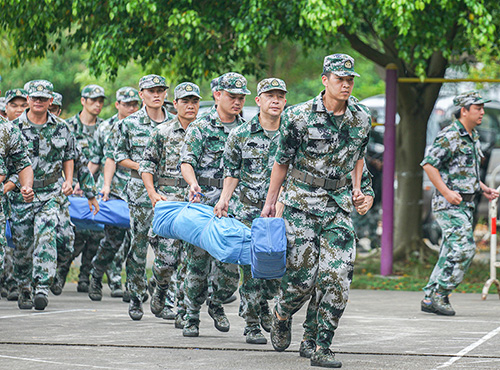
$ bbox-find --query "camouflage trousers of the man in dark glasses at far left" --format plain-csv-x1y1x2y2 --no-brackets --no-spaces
11,194,60,294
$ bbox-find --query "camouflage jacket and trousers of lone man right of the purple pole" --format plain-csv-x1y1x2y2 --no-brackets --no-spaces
420,120,483,297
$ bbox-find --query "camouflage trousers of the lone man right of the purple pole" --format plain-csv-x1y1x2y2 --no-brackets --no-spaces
423,208,476,296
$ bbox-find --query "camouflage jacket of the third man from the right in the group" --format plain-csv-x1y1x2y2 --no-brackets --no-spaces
180,106,245,205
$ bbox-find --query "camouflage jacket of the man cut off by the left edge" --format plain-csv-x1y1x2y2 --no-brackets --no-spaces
0,117,31,176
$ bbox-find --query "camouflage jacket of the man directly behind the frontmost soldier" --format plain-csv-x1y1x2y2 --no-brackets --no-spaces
223,115,280,207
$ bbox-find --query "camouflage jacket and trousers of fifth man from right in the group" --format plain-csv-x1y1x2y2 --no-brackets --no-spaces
114,102,174,300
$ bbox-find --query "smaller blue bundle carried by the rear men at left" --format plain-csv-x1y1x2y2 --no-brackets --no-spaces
68,196,130,230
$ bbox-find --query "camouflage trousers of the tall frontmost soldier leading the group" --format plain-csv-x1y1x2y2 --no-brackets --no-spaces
276,206,356,348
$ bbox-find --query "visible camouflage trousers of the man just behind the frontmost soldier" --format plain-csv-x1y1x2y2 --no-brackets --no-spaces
239,265,280,326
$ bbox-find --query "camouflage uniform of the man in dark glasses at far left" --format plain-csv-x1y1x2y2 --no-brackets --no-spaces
9,105,75,294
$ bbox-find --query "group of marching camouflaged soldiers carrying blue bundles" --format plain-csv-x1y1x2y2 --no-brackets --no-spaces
0,54,374,367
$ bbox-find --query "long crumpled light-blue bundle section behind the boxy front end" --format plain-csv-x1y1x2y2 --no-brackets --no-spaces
153,201,251,265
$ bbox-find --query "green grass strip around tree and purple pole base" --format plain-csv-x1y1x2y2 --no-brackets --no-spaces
351,254,494,293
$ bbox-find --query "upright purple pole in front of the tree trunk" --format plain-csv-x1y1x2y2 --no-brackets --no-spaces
380,63,398,276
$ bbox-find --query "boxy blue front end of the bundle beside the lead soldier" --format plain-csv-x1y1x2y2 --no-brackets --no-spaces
251,217,286,279
